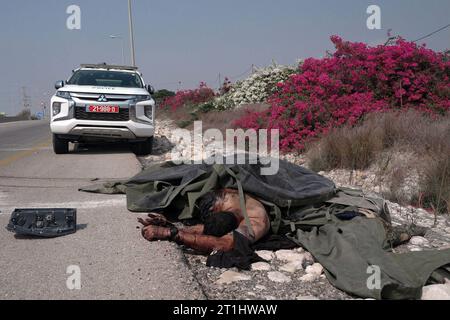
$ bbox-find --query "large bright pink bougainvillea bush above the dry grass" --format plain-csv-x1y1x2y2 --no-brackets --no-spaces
235,36,450,151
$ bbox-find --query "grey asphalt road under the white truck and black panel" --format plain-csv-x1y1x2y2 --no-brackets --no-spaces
0,121,204,299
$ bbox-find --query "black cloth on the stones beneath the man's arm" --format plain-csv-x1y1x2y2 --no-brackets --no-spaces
206,231,266,270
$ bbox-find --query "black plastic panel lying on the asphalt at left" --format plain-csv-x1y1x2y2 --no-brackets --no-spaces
6,209,77,238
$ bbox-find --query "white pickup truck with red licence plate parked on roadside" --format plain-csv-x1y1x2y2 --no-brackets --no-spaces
50,64,155,155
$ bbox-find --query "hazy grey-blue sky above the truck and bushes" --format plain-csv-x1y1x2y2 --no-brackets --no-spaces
0,0,450,115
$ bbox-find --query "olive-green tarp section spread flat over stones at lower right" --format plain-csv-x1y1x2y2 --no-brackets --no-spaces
290,217,450,299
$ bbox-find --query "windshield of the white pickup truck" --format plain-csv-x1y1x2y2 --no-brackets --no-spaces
67,70,143,88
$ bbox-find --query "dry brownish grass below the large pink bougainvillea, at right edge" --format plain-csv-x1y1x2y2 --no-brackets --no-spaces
307,111,450,212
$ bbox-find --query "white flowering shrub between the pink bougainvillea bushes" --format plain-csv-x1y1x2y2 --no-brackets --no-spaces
214,65,298,110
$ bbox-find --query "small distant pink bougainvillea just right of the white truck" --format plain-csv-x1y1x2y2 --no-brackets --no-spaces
160,82,215,111
